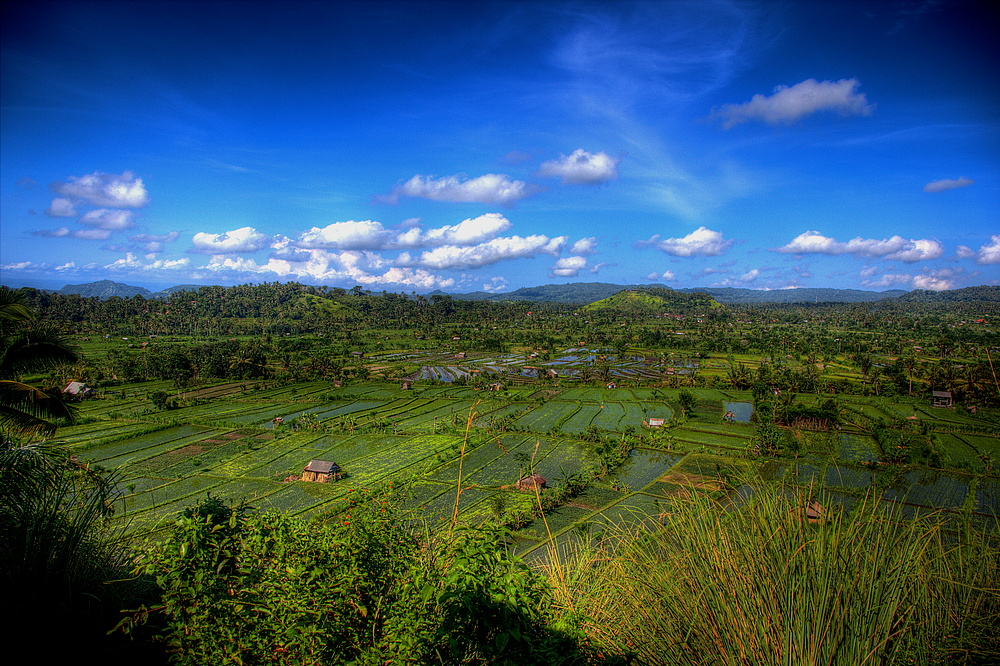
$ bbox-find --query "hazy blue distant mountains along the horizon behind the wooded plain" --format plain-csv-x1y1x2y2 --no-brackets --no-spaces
9,280,1000,305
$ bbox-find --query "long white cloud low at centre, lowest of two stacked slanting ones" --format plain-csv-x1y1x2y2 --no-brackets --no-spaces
396,234,568,269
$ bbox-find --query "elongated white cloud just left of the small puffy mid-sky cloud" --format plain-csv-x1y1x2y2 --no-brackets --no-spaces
383,173,537,206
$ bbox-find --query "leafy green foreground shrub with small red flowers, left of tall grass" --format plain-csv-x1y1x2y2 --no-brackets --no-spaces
127,490,580,666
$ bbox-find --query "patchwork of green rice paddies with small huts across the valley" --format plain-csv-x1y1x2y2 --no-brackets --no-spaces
59,373,1000,544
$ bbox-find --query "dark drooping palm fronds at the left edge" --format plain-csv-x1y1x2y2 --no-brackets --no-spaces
0,287,78,438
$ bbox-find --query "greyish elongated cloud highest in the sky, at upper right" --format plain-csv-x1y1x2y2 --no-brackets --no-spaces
710,79,875,129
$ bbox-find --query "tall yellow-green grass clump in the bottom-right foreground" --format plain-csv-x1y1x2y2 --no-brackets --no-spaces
551,487,1000,666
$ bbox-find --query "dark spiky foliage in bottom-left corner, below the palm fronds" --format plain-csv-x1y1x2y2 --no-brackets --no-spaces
0,443,130,636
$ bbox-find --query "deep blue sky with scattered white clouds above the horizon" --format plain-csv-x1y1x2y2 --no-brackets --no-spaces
0,0,1000,292
